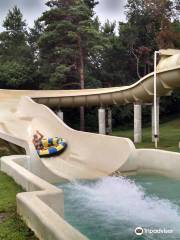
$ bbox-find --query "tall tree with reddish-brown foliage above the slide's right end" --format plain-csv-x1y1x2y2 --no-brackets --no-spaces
120,0,178,77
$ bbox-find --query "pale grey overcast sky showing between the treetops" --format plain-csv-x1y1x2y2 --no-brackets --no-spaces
0,0,126,31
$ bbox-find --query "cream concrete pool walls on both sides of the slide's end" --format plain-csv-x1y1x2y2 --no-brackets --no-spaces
0,149,180,240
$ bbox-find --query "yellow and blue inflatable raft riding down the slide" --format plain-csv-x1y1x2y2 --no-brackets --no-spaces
37,137,67,157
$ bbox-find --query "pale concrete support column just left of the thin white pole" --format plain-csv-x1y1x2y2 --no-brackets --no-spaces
134,103,142,143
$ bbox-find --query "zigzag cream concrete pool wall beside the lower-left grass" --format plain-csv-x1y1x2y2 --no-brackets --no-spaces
0,155,88,240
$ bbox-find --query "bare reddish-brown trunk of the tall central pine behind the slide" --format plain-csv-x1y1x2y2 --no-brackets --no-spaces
78,36,85,131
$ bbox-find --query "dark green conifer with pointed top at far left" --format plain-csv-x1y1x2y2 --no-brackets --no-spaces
0,7,34,88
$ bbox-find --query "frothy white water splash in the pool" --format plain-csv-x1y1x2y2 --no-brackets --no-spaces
62,177,180,232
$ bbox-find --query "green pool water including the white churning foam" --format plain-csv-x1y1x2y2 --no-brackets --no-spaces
60,175,180,240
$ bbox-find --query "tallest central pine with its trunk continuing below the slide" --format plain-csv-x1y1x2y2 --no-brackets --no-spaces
39,0,102,130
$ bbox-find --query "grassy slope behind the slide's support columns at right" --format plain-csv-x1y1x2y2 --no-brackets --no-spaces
113,117,180,152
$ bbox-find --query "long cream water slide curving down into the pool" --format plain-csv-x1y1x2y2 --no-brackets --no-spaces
0,49,180,182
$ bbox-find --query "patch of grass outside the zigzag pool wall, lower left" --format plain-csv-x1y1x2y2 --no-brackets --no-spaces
0,172,37,240
